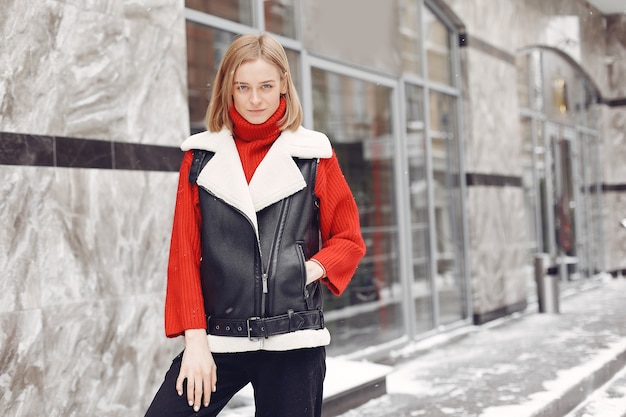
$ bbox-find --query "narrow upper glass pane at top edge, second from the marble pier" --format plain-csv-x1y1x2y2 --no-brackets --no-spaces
400,0,422,75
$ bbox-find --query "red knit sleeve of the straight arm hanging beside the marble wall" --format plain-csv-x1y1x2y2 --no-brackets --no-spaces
165,151,206,337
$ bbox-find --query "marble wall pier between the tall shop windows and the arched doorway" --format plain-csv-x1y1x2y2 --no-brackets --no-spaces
463,44,530,316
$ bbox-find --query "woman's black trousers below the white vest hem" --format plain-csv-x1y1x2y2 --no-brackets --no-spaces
146,347,326,417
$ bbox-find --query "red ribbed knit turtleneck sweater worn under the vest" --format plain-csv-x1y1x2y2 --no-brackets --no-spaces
165,99,365,337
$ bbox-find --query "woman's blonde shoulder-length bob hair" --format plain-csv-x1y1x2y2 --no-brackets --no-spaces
206,33,302,132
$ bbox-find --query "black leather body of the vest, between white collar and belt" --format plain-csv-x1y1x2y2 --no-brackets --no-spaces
189,150,323,330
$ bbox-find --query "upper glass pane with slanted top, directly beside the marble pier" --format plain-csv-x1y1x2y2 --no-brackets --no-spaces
423,7,452,85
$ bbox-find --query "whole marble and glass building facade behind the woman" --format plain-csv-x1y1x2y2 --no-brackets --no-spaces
0,0,626,416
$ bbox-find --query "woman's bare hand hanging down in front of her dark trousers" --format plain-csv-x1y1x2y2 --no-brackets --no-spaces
176,329,217,412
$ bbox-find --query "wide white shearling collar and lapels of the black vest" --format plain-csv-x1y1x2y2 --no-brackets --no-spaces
181,127,332,236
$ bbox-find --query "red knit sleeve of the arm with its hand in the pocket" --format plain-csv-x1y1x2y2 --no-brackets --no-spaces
313,152,365,295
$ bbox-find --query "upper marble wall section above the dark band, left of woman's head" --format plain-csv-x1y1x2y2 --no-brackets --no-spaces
0,0,188,145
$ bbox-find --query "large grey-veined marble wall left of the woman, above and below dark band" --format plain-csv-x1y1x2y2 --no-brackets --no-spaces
0,0,188,417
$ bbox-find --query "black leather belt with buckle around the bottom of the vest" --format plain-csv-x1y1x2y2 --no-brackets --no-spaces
207,310,324,339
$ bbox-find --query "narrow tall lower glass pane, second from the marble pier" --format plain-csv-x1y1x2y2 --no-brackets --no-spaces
405,84,434,332
